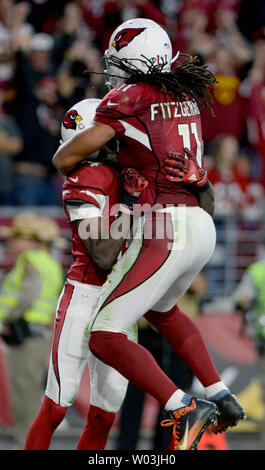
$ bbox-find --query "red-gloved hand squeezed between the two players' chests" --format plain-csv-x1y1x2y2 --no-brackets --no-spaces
121,168,148,210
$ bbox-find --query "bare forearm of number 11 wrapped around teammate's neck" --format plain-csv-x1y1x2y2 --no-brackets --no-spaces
53,122,116,175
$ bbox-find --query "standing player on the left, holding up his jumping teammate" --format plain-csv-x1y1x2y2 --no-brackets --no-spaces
25,99,140,450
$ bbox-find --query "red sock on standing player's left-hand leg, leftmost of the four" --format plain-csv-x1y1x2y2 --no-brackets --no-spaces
24,396,66,450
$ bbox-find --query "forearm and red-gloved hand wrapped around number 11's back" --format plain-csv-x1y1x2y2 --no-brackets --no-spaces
165,148,215,216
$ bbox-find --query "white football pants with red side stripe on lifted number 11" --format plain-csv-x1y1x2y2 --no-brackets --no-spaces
90,206,216,335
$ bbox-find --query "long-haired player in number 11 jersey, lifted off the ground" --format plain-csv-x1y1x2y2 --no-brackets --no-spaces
54,18,245,450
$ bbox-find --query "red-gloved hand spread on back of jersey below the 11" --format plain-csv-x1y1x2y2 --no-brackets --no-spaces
165,148,207,188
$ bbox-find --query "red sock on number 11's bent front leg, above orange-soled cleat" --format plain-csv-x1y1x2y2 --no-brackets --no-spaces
89,331,177,405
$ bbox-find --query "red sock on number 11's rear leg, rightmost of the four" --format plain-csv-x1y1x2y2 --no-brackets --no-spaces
145,306,221,387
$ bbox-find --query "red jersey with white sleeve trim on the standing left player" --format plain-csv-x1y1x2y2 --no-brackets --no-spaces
62,163,121,285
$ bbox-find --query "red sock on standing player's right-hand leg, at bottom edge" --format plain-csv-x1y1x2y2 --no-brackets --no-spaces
77,405,116,450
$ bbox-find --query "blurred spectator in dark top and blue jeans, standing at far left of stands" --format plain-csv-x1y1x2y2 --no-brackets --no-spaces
9,28,65,206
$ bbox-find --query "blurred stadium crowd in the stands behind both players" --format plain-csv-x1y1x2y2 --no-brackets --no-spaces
0,0,265,217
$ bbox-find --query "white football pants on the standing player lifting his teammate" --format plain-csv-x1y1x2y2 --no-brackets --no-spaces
45,279,137,413
